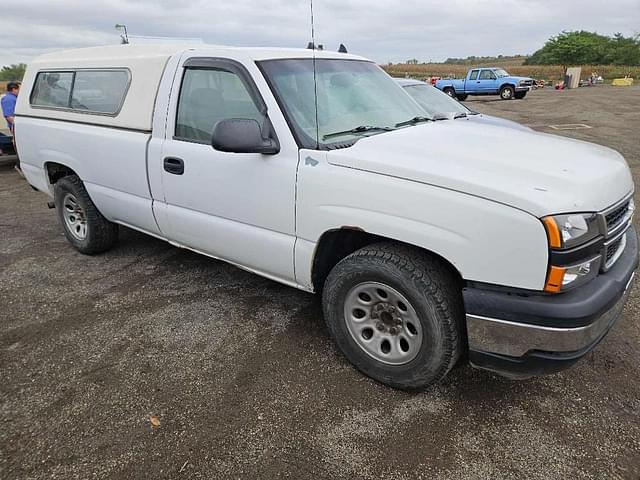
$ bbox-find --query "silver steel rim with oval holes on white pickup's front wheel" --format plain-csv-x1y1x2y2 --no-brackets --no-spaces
344,282,423,365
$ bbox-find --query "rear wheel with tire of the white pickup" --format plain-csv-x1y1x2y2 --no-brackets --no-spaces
54,175,118,255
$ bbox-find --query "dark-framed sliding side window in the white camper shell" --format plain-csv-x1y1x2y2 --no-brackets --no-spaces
30,69,131,116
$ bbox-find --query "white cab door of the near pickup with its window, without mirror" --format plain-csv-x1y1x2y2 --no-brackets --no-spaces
150,57,298,283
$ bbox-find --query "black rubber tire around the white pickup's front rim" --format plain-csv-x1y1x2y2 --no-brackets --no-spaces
322,243,465,390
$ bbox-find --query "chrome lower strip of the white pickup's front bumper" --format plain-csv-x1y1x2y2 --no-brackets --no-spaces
467,274,635,357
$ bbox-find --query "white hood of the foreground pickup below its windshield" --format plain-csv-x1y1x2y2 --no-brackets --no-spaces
327,120,634,217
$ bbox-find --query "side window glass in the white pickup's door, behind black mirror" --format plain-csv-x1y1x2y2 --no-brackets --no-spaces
175,68,263,143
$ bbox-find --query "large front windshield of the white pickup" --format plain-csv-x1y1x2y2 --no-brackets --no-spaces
259,58,424,148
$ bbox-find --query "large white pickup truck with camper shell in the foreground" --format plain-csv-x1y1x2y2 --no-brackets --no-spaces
16,45,638,389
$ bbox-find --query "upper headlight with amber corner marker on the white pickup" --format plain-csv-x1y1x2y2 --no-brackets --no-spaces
542,213,600,250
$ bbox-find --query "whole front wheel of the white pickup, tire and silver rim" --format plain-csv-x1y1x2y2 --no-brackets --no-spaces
323,243,464,389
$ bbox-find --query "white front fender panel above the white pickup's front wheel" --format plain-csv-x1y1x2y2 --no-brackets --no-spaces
296,151,548,290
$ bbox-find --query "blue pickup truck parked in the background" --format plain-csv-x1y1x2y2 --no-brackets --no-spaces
436,67,533,101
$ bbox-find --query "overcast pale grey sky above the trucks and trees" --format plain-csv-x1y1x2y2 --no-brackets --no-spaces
0,0,640,65
